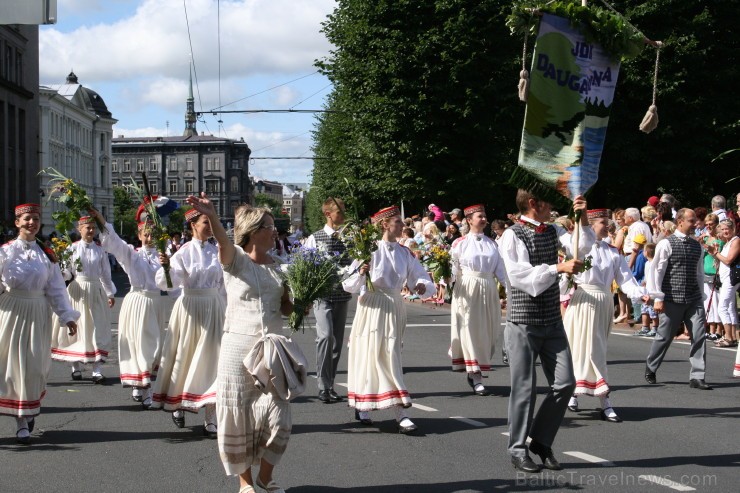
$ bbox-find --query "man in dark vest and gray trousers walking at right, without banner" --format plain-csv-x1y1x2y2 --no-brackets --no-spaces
645,209,712,390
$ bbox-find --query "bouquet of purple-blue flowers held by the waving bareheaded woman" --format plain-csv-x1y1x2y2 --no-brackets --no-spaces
283,246,340,332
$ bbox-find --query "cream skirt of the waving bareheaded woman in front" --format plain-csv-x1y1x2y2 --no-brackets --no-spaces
216,332,293,475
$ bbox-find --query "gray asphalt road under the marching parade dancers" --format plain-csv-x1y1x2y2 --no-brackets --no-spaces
0,279,740,493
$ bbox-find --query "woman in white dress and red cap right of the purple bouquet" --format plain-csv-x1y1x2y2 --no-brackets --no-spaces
342,206,434,433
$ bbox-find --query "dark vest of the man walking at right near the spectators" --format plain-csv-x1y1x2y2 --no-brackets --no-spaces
660,235,702,304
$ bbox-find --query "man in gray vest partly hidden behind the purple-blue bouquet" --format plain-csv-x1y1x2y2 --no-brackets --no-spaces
304,197,352,404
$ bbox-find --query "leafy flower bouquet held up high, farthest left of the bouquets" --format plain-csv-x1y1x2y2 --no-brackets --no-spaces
39,167,105,232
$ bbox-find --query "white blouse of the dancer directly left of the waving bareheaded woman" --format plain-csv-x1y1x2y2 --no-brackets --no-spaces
156,239,226,300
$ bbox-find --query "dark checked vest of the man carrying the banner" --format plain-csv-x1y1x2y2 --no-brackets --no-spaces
506,224,562,325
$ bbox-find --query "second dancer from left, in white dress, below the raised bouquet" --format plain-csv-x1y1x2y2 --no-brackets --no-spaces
51,216,116,384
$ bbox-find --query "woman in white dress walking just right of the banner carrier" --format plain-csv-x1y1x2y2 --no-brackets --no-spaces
563,209,649,423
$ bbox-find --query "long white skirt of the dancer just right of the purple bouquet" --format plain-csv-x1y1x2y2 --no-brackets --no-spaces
347,288,411,411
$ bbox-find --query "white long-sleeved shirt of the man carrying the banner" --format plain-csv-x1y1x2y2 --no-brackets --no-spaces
499,216,596,296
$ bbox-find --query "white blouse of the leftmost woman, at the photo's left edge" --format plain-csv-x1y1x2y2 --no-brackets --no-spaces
0,238,80,324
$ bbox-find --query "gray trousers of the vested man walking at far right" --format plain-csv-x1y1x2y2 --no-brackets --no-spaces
647,300,707,379
